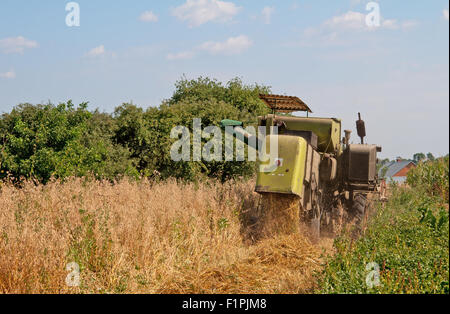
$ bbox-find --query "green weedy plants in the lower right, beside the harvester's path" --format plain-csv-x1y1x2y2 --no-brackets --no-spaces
318,160,449,294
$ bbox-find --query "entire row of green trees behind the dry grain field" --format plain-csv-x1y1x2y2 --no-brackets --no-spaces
0,77,269,183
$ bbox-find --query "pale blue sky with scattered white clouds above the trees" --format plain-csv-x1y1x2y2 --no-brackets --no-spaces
0,0,449,158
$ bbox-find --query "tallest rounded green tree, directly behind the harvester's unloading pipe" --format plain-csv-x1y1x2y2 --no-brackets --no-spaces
148,77,270,181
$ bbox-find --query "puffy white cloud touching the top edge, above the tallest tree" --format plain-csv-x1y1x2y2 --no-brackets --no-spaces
172,0,241,27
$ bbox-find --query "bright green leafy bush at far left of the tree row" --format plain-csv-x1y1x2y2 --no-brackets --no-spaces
0,101,137,183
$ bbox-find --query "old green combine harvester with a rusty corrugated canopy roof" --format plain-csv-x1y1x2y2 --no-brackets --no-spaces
222,95,381,240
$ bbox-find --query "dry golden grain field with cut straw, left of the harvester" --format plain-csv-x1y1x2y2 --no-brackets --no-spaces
0,179,322,293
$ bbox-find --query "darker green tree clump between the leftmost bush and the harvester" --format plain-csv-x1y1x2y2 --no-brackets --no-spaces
114,77,269,181
